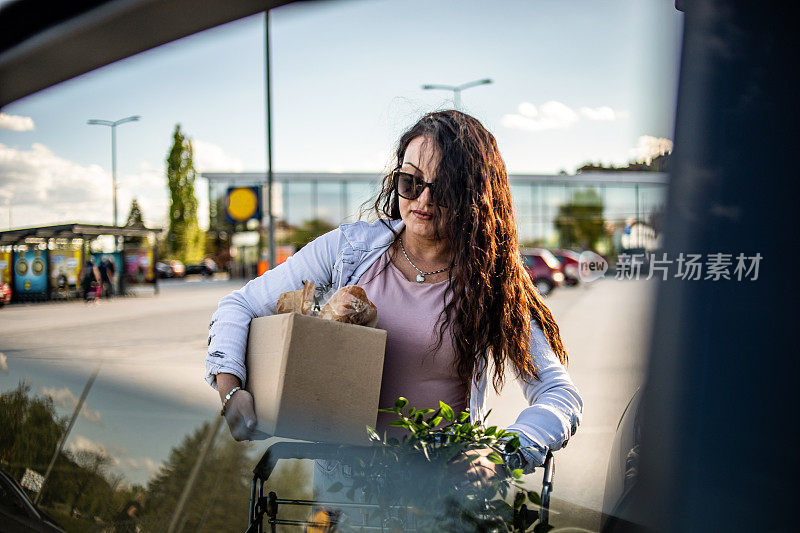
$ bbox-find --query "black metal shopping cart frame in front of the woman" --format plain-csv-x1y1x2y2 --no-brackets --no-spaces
247,442,555,533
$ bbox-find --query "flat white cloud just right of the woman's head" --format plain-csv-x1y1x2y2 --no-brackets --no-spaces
500,100,628,131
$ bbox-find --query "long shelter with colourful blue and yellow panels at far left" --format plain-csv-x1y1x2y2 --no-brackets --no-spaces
0,223,160,302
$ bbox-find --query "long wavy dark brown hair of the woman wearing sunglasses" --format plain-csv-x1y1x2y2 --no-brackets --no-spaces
372,110,568,391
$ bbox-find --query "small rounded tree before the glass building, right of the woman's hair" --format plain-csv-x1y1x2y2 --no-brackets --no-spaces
554,188,605,249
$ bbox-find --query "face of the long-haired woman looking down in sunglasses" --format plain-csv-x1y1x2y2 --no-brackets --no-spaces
398,137,442,240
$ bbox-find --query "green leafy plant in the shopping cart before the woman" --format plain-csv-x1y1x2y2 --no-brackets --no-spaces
329,397,550,532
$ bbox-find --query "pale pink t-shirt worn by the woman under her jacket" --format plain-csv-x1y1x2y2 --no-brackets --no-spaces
357,251,467,433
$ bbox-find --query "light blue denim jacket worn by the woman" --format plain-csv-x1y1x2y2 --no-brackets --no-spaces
206,220,583,472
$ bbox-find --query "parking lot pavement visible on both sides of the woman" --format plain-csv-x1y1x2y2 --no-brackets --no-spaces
0,274,655,529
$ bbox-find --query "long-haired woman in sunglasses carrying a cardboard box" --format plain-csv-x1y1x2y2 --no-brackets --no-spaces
206,111,583,478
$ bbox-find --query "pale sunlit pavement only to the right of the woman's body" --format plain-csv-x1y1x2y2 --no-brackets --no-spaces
489,280,655,520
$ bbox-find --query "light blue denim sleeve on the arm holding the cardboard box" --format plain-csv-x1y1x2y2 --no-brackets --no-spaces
205,228,343,388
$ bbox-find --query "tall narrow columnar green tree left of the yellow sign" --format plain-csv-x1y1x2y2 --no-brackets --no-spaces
167,124,205,263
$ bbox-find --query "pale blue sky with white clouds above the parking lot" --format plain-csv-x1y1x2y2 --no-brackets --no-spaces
0,0,683,230
